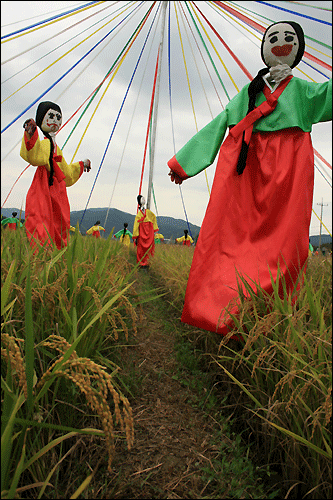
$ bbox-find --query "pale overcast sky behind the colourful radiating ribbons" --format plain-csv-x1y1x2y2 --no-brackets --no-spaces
1,0,332,234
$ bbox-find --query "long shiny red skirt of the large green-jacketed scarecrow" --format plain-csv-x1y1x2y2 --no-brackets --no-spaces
181,128,314,338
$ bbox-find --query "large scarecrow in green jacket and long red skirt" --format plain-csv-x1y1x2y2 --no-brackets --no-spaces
168,21,332,338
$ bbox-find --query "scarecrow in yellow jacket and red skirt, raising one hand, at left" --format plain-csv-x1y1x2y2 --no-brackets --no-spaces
20,101,91,249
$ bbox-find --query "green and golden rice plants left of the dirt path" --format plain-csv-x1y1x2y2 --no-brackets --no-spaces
1,231,137,498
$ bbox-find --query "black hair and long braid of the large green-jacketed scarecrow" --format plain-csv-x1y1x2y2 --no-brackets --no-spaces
237,21,305,175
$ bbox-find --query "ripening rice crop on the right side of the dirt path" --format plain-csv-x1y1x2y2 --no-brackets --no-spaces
150,247,332,498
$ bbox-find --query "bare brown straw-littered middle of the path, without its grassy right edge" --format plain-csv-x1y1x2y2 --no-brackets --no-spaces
109,275,226,498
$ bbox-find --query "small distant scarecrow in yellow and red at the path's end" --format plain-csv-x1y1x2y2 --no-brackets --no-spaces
132,194,158,270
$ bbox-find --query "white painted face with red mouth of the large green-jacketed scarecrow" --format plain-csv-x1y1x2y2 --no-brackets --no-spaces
262,23,299,68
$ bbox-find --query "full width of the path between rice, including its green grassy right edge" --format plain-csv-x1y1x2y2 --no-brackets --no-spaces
99,271,279,499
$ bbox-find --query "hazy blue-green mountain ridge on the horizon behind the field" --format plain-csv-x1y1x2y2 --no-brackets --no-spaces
1,208,200,239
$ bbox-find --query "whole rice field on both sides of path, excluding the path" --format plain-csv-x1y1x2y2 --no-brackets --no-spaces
1,230,332,498
